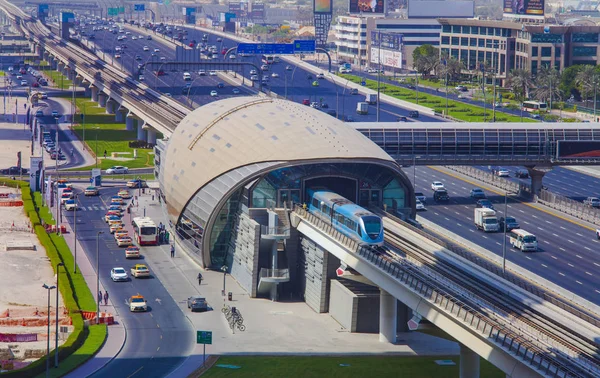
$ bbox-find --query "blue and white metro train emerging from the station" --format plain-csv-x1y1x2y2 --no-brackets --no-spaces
308,190,383,246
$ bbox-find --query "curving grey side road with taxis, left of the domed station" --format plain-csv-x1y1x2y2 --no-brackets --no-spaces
63,186,195,378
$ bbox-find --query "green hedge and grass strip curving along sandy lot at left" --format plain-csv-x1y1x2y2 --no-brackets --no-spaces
0,179,107,378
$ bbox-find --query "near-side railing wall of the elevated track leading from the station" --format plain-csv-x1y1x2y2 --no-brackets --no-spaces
295,206,577,378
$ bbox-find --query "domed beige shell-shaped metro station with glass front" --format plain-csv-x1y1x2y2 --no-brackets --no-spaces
155,97,415,312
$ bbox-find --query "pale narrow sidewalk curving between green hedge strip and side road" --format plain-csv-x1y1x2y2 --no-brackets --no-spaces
56,185,127,378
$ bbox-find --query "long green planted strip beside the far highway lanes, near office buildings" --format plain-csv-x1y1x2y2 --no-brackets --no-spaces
339,74,535,122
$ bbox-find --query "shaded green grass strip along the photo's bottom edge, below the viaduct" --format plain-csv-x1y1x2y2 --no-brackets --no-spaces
202,356,506,378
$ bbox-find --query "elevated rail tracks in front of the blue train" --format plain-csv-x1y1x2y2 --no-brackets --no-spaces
382,224,600,377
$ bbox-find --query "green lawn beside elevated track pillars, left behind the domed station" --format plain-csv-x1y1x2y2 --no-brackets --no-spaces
74,98,157,170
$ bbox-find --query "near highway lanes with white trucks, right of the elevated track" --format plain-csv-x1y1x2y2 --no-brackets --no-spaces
406,166,600,304
